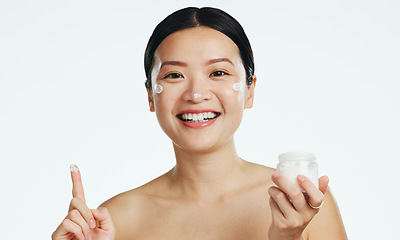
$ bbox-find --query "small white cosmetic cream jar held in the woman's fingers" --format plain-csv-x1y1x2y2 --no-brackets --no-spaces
277,152,319,188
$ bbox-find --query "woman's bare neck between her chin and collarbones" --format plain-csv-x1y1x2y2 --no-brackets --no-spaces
171,139,245,199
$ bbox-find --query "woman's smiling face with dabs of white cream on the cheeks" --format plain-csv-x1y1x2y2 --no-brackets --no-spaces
148,27,255,152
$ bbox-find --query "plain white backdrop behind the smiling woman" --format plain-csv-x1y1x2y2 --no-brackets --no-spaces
0,0,400,239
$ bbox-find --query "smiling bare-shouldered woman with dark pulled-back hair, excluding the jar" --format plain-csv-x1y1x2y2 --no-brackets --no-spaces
52,8,346,240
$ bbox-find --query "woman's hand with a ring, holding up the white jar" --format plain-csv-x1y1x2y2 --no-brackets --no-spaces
268,174,329,240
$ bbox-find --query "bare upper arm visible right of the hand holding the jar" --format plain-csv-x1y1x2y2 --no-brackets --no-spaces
306,189,347,240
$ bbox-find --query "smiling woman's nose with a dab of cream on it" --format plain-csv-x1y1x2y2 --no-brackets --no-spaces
182,76,212,103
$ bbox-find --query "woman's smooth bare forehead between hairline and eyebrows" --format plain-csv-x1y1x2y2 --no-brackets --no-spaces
155,26,241,63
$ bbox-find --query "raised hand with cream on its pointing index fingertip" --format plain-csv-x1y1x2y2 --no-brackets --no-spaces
52,165,115,240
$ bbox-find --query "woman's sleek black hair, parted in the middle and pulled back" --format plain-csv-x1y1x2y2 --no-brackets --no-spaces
144,7,254,89
